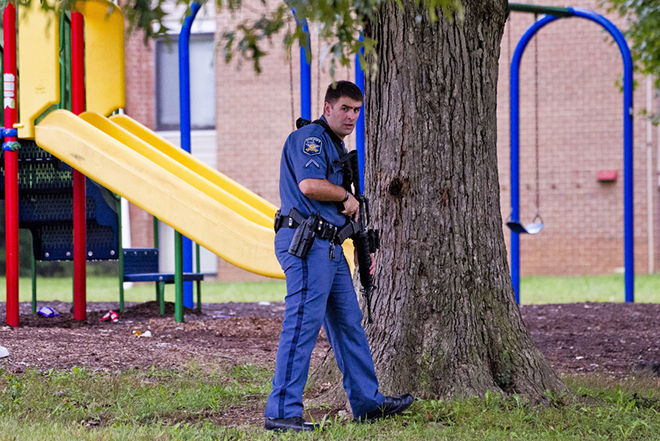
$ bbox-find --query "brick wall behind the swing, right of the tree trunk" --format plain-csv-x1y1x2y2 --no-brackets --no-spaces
498,0,658,274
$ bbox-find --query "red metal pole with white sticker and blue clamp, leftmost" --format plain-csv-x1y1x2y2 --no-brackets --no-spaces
2,3,18,326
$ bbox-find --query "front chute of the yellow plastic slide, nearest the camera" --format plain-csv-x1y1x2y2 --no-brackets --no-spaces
35,110,284,278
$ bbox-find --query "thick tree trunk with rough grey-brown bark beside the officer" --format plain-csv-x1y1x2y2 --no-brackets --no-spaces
315,0,566,401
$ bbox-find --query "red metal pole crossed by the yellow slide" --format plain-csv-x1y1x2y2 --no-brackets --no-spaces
71,12,87,320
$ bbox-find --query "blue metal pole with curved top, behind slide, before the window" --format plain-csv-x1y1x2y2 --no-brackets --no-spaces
175,2,202,308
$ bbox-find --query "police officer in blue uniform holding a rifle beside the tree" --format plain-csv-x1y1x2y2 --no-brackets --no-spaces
265,81,413,431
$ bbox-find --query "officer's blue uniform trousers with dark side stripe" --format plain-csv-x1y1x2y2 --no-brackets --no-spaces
265,228,385,418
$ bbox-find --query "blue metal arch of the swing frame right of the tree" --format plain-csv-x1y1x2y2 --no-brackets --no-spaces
510,8,635,302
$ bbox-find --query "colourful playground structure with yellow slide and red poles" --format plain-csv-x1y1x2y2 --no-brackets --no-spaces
3,0,360,326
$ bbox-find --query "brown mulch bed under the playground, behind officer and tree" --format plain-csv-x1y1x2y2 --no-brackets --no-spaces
0,302,660,425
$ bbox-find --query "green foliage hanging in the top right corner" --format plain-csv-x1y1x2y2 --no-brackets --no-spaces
605,0,660,87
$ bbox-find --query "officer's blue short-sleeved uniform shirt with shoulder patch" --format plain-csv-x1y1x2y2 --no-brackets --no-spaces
280,117,348,227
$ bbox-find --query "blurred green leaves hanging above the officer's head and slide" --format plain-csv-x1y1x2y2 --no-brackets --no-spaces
123,0,462,73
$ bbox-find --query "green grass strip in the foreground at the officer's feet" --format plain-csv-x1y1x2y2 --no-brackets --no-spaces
0,365,660,441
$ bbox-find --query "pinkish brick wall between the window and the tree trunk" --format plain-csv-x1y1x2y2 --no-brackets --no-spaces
216,2,355,280
